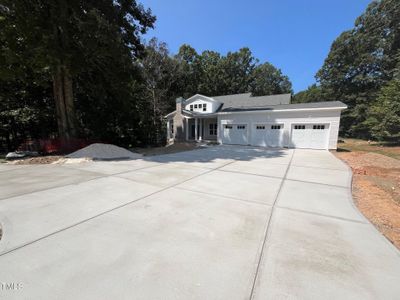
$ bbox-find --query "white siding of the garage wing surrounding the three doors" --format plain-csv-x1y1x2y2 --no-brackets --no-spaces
218,109,340,149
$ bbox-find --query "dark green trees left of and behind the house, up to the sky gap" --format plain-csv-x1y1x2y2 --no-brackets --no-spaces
0,0,292,150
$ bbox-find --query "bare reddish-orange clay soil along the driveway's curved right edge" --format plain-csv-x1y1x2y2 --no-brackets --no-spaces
334,151,400,249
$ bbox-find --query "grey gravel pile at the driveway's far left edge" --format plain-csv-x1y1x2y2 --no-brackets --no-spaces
65,143,142,160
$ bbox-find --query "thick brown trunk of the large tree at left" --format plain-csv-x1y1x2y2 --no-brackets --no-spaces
53,66,76,139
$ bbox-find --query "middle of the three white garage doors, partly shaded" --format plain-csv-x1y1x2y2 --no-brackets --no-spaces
251,124,283,147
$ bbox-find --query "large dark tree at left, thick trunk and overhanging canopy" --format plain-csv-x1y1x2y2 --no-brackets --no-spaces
1,0,155,138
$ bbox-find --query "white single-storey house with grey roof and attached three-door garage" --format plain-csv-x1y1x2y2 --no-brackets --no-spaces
166,93,347,149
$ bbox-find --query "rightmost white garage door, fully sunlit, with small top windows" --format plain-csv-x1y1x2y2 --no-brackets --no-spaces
290,124,329,149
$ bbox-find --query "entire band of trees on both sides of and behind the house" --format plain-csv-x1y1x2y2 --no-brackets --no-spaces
0,0,400,151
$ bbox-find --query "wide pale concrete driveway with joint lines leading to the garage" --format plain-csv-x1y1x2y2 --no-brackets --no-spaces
0,146,400,299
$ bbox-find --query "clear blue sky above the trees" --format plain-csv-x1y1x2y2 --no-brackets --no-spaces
139,0,371,93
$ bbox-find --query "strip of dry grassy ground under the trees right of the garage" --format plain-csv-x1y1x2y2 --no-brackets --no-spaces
337,138,400,160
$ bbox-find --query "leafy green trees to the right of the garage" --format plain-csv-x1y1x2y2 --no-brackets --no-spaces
295,0,400,142
